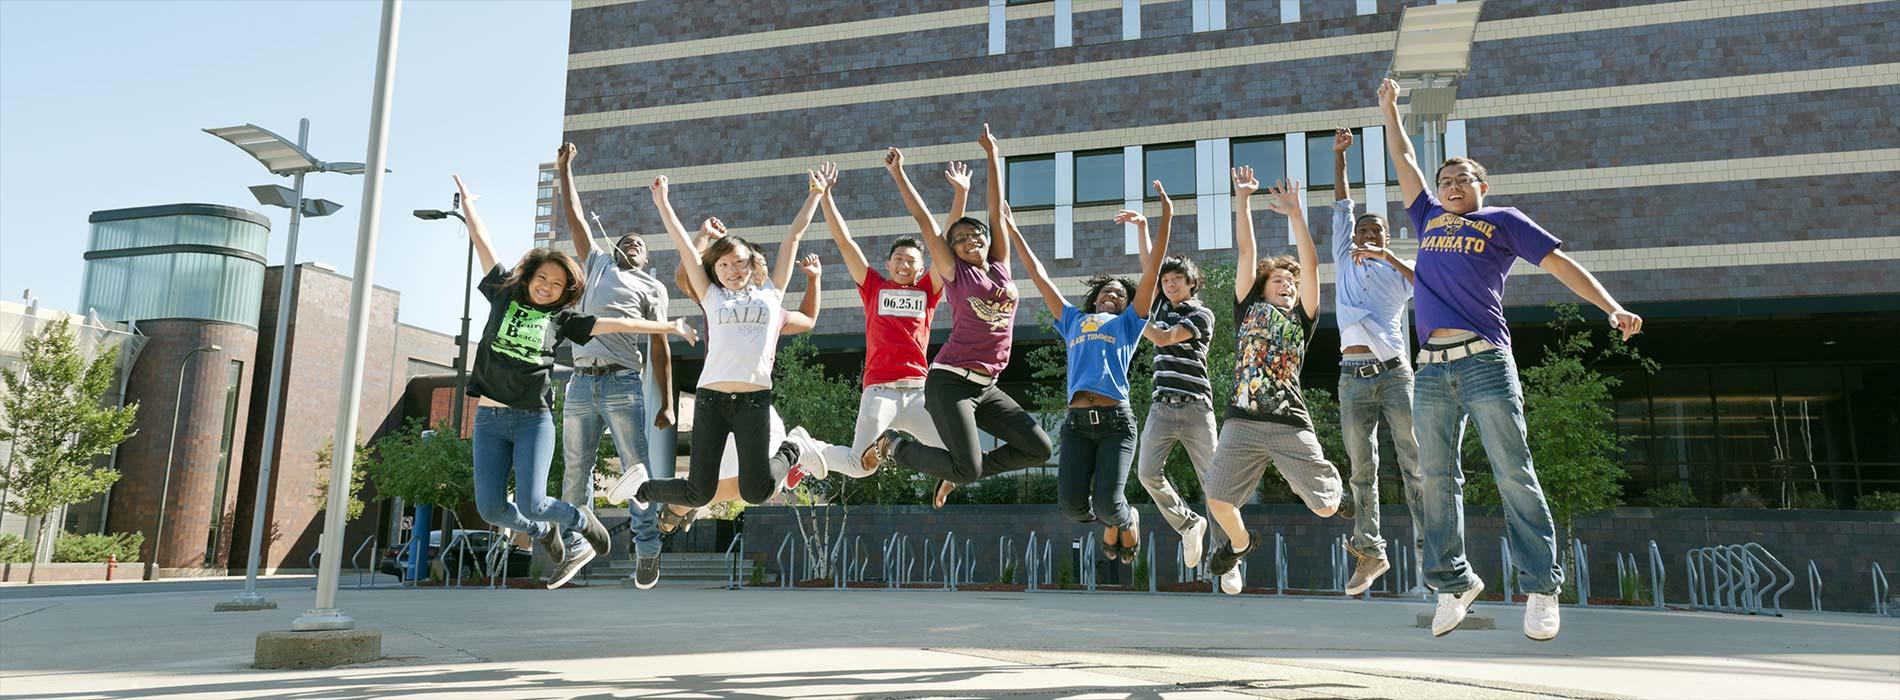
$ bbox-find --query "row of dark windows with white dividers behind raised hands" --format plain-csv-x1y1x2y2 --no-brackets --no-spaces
1005,129,1425,209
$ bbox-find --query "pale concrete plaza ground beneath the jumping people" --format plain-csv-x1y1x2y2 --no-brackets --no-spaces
0,586,1900,700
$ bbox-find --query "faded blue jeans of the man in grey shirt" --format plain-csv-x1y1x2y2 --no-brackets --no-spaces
561,369,673,557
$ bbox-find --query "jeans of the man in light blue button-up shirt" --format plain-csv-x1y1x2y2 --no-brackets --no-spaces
1340,360,1421,559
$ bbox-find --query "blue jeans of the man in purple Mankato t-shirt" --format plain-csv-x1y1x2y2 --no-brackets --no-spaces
1412,350,1564,593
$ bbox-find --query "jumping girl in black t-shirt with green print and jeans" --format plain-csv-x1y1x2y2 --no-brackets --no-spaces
456,177,697,588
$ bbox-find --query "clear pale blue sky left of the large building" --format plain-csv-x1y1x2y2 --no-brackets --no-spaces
0,0,568,333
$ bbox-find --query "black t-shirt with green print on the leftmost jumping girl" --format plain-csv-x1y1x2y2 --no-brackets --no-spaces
467,264,595,409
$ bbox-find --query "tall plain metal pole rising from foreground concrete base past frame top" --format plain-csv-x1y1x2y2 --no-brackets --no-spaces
291,0,403,632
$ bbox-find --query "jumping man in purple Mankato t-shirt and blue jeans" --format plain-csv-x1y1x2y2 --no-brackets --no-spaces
1379,80,1644,641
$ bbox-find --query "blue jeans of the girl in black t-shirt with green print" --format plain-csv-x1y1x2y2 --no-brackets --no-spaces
475,405,581,536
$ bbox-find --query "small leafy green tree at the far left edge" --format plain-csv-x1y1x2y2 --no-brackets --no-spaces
0,320,139,582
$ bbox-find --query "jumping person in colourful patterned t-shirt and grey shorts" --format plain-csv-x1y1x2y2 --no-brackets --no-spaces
1205,167,1351,593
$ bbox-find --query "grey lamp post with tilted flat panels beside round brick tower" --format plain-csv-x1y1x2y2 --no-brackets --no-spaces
205,120,363,611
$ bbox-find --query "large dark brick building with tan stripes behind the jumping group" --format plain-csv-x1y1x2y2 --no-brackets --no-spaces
564,0,1900,506
